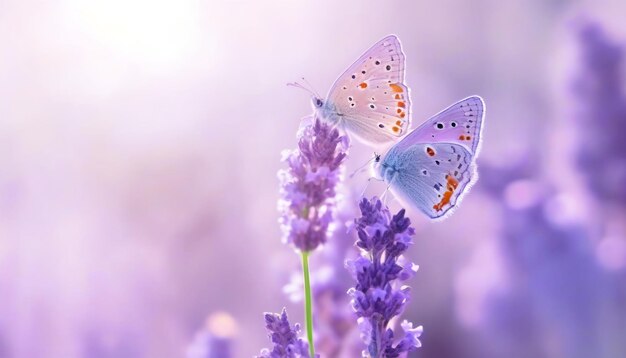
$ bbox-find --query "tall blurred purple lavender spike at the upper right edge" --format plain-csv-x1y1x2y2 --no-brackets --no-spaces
572,23,626,204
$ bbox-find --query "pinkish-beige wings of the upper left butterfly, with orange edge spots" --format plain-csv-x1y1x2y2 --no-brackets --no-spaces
327,35,411,144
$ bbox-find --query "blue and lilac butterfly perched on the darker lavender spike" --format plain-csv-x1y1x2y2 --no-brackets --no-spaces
373,96,485,219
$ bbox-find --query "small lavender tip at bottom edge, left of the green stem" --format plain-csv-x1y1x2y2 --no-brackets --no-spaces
257,308,310,358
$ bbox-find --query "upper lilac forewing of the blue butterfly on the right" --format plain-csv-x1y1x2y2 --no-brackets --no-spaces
398,96,485,156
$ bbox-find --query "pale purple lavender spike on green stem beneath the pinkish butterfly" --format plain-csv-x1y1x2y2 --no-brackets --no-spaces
278,120,347,252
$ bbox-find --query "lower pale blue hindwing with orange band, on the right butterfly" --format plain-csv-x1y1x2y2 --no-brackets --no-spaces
380,143,478,219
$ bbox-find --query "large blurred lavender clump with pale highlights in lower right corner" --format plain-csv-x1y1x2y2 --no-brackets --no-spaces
466,161,626,358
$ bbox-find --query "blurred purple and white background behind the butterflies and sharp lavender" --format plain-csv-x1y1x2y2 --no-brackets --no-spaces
0,0,626,358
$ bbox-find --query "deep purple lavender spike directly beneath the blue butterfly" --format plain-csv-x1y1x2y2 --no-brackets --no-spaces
346,198,423,358
